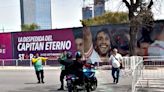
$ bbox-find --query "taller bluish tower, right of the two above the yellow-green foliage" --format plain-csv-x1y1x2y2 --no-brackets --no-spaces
94,0,105,17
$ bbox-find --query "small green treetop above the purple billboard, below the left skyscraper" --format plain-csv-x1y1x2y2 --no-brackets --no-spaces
21,23,39,31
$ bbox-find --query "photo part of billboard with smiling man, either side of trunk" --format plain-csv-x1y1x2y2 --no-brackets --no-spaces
73,23,164,63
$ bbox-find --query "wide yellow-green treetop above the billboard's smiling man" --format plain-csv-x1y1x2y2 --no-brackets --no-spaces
81,12,128,26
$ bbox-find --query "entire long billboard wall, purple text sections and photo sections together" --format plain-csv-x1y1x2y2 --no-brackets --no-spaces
0,23,164,65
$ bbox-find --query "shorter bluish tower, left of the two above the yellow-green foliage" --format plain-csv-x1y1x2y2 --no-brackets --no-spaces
82,7,92,19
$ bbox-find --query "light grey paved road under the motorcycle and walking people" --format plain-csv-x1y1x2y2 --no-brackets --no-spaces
0,69,131,92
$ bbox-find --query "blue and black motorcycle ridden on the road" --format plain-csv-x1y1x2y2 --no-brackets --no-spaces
66,64,97,92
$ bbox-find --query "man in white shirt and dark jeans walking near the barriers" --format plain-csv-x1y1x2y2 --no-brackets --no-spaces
109,48,122,84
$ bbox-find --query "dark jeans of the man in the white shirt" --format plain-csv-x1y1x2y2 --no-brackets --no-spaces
112,67,120,83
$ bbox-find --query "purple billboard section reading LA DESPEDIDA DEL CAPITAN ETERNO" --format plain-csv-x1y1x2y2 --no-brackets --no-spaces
12,29,76,59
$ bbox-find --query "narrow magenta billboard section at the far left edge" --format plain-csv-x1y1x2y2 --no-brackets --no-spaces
0,33,12,59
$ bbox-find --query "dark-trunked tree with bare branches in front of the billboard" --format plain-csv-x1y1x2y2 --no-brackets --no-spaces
122,0,153,55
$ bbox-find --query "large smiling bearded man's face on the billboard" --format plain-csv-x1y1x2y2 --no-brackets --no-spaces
96,32,110,55
